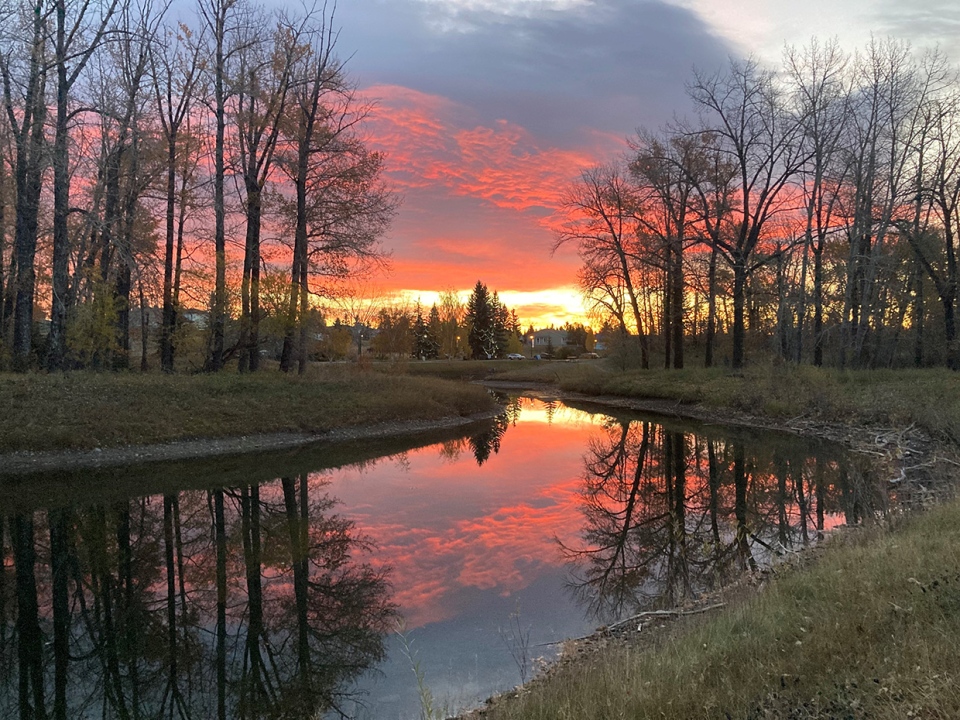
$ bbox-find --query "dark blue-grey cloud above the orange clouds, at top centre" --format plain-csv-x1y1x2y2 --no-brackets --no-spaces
339,0,732,144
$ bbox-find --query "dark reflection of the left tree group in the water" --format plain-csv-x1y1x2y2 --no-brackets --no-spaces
0,476,393,719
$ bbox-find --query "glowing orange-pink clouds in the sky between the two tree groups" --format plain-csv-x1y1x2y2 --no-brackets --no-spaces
352,85,620,325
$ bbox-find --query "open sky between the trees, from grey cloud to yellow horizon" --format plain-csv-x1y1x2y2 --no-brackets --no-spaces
335,0,960,327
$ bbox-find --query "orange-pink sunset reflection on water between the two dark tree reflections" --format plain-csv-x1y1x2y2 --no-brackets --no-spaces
318,401,593,627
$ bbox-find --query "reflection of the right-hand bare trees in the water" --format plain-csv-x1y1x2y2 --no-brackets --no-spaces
563,420,883,619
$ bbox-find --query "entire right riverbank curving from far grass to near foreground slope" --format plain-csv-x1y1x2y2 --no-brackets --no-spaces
444,363,960,720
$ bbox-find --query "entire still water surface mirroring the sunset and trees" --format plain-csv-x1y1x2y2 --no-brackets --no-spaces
0,398,888,718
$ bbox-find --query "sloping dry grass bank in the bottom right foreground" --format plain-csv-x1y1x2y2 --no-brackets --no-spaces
486,504,960,720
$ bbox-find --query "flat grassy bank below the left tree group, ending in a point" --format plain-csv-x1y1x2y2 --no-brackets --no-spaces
0,366,494,452
